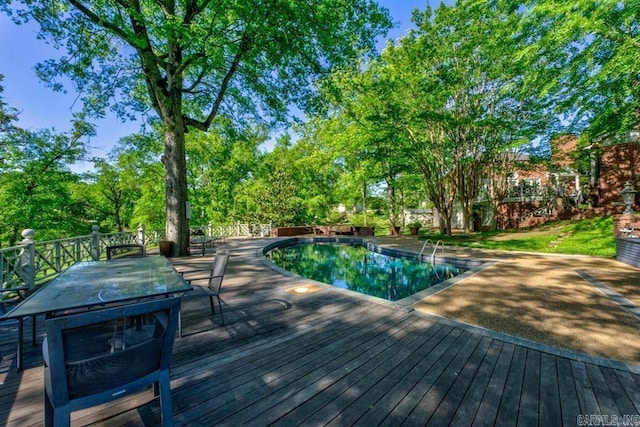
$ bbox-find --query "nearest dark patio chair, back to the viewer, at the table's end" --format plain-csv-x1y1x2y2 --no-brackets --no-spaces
42,298,180,426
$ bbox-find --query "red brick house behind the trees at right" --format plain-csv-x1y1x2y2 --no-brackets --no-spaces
476,132,640,230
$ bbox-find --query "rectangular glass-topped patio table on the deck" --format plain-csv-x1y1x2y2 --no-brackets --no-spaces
1,256,192,370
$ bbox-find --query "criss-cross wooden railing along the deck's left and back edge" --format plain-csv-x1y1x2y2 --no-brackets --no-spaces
0,224,271,298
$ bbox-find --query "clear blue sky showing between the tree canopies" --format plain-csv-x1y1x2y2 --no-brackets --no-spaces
0,0,440,167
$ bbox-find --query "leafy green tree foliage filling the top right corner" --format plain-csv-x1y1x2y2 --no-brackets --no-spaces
521,0,640,136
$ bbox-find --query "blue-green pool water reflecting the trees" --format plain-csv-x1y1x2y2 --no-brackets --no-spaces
265,243,466,301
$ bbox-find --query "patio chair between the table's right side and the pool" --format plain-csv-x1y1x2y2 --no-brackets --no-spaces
178,250,229,337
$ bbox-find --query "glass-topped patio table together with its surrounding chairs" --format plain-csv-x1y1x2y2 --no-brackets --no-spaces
0,245,229,426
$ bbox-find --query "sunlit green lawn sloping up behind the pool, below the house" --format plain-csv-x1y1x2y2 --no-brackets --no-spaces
421,217,616,257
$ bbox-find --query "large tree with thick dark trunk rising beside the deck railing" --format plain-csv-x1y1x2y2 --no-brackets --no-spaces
0,0,390,255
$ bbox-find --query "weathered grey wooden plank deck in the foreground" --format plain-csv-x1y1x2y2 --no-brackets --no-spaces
0,240,640,426
